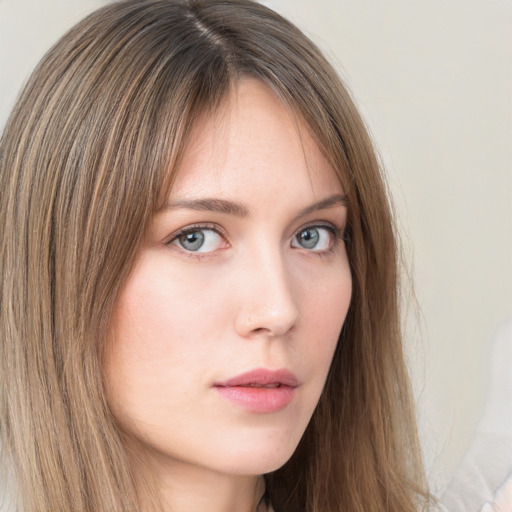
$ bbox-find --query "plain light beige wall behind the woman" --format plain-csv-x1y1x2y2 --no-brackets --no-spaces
0,0,512,487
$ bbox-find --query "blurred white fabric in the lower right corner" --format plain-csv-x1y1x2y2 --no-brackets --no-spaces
441,320,512,512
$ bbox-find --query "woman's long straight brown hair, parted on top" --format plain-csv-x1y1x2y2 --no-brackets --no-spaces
0,0,426,512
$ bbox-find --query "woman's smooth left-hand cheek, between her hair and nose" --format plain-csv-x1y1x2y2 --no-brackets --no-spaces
104,254,234,414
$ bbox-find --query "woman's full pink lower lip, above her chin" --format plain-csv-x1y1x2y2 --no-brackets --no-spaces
214,386,295,413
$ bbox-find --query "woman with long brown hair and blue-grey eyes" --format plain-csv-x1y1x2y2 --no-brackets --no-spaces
0,0,427,512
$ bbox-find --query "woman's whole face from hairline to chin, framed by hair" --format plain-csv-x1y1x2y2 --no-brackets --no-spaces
105,79,351,475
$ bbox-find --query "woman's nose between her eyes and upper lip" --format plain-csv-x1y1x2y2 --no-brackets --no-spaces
235,251,299,338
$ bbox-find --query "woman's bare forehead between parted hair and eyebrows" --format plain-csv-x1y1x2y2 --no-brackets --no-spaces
171,79,342,204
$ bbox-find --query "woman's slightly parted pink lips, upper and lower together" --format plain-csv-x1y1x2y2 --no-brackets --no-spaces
213,368,299,413
